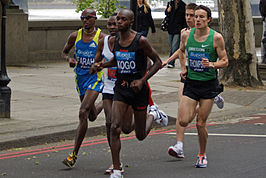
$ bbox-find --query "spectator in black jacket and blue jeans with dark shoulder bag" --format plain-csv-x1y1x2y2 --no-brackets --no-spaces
165,0,187,68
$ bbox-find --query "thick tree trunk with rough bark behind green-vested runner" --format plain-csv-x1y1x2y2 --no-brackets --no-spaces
218,0,263,87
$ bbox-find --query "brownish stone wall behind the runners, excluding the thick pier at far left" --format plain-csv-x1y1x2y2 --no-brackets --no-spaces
28,18,262,62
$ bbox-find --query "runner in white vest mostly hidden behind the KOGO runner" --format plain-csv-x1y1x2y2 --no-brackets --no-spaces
95,13,167,173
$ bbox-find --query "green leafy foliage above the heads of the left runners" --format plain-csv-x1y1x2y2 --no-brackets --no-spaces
73,0,122,18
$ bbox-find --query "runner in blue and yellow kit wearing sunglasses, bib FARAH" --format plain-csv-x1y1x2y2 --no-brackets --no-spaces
62,9,104,168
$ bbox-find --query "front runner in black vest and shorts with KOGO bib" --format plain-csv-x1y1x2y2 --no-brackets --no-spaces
91,9,168,177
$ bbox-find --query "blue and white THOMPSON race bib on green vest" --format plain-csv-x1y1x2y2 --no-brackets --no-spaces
188,51,210,72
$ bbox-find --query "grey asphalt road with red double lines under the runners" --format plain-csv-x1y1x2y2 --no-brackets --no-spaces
0,113,266,178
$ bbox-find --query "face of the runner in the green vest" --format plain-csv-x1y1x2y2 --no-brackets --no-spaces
195,9,211,29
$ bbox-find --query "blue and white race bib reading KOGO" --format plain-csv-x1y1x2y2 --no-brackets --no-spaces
115,51,136,74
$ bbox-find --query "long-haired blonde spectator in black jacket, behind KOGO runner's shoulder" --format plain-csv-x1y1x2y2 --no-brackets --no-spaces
136,0,155,37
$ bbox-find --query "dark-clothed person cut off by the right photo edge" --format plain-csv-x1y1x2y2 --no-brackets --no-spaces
259,0,266,64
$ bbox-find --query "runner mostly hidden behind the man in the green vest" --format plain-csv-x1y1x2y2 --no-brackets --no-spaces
162,3,224,158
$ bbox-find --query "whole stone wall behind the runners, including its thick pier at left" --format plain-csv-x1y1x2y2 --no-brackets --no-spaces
1,9,262,65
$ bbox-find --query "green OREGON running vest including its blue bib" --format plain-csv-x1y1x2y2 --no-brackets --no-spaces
186,28,218,81
